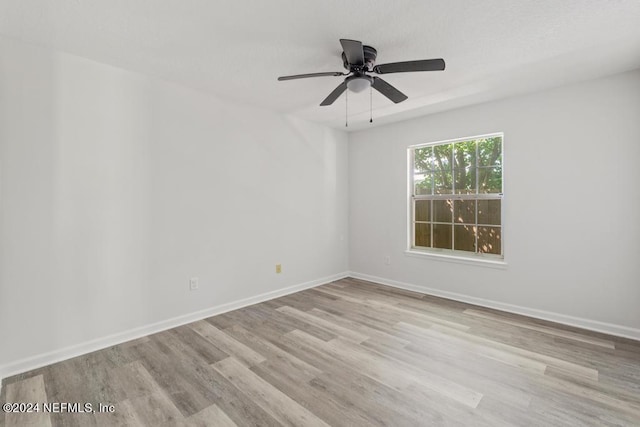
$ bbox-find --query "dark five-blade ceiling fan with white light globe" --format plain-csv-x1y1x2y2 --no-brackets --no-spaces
278,39,445,106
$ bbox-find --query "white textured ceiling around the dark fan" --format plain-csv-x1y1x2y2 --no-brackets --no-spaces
0,0,640,130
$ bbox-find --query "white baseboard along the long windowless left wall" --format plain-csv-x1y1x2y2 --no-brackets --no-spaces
0,272,349,390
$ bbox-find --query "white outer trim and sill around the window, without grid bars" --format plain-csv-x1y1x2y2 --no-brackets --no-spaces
405,132,508,269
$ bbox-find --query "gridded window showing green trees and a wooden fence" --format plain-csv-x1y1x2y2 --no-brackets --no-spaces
409,134,504,258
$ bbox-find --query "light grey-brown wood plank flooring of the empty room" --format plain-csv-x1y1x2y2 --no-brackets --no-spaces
0,279,640,427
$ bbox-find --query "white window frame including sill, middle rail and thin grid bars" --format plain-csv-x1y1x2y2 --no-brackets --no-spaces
405,132,506,266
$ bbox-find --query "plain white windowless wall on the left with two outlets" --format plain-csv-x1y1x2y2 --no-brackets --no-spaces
0,39,348,376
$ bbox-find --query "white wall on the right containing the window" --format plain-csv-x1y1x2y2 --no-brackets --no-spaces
349,71,640,339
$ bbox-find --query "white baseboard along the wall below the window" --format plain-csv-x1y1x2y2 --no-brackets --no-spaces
349,271,640,341
